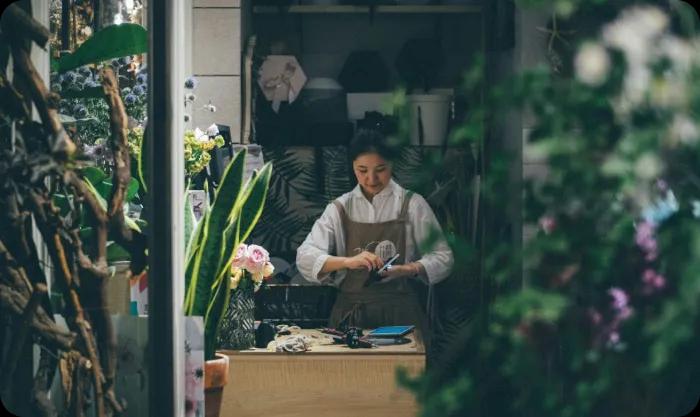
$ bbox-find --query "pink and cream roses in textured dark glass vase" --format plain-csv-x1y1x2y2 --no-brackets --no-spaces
218,244,274,350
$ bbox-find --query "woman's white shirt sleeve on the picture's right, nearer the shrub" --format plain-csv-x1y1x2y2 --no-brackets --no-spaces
408,194,454,284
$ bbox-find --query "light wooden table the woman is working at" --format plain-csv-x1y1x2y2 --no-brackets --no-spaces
221,330,425,417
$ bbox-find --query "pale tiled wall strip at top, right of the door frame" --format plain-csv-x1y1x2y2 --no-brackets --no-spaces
187,0,241,142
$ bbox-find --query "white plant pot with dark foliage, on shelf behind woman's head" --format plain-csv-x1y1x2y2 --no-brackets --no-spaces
407,92,452,146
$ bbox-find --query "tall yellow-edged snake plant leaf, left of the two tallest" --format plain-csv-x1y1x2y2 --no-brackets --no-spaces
185,151,246,316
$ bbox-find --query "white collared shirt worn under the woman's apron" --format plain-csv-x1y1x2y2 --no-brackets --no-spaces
297,180,454,285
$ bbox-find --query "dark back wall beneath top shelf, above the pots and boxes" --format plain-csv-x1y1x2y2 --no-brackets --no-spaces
249,13,481,87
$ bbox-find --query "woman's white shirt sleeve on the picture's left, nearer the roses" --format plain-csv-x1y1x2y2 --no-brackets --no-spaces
297,203,342,284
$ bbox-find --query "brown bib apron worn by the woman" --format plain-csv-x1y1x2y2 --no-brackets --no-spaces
329,191,428,339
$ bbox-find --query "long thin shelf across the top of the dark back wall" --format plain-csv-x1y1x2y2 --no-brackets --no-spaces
253,4,481,14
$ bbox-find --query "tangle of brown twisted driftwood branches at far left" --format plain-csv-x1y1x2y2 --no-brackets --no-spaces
0,3,146,417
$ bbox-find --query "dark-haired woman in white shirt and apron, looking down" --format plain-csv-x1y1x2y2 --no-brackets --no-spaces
297,130,453,334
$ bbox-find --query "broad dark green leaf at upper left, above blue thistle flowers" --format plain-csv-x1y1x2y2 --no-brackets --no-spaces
58,23,148,72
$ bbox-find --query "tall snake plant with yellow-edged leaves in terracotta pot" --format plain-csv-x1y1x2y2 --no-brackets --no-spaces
184,150,272,416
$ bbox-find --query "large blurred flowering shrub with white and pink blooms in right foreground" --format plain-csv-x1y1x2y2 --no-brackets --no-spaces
409,0,700,417
